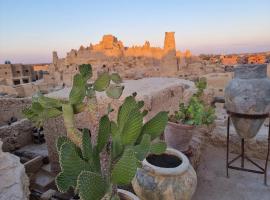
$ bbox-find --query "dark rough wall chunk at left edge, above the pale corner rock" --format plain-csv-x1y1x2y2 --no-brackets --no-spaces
0,119,34,151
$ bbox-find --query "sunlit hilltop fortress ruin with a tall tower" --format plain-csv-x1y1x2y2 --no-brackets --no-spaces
44,32,191,85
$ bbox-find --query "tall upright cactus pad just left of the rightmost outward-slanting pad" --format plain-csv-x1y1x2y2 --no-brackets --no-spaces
121,108,143,145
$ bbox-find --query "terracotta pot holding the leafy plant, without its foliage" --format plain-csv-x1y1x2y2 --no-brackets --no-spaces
164,122,195,152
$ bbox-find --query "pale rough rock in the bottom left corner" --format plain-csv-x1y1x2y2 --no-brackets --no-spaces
0,141,30,200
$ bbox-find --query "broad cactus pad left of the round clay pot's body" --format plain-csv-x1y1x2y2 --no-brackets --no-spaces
112,149,138,185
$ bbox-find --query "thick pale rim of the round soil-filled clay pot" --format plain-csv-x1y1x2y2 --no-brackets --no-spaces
142,148,189,176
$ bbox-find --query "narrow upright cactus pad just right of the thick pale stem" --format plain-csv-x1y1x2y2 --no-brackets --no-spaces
82,128,93,162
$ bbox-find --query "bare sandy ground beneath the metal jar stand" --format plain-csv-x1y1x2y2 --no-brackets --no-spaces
193,145,270,200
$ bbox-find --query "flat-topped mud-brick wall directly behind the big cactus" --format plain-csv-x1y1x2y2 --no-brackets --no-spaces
44,78,195,172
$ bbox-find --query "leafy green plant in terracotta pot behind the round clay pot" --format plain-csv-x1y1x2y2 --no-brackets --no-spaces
164,79,215,153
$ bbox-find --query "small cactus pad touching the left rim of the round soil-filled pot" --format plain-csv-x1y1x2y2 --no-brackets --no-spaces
134,134,151,161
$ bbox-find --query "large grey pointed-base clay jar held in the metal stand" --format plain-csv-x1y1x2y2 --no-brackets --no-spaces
225,64,270,139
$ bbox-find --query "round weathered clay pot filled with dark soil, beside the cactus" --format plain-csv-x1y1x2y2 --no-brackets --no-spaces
132,148,197,200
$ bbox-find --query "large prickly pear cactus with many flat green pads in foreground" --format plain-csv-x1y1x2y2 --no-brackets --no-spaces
24,65,168,200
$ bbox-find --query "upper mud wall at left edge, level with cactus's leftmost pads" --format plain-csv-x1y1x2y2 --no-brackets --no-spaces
0,98,31,126
